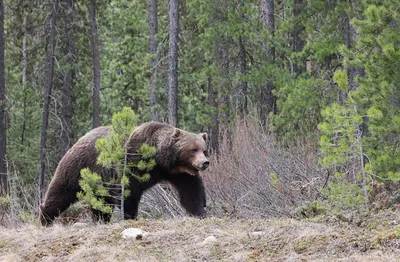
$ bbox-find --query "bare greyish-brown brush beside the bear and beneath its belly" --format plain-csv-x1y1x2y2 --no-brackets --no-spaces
141,120,326,218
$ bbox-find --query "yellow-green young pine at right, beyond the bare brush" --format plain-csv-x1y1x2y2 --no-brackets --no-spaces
318,70,373,206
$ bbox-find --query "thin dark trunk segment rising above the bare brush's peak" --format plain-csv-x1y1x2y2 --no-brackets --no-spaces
236,36,248,118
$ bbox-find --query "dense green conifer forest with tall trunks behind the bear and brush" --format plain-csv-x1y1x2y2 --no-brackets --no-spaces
0,0,400,217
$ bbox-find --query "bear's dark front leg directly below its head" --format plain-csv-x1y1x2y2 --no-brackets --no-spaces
168,173,206,218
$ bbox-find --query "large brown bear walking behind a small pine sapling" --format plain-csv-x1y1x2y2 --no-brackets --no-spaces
40,122,210,225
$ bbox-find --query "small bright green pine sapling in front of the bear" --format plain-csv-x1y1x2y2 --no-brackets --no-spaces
78,107,156,218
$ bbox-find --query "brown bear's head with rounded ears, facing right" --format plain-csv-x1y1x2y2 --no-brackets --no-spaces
171,128,210,176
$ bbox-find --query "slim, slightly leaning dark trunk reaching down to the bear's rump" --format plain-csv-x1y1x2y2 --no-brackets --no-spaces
38,0,58,203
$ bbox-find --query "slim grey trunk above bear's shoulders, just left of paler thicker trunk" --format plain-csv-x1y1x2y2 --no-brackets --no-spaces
149,0,159,121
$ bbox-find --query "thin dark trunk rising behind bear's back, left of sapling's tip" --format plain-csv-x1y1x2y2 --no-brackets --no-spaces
89,0,100,128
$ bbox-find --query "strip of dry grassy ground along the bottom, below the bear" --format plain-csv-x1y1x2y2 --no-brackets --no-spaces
0,211,400,262
